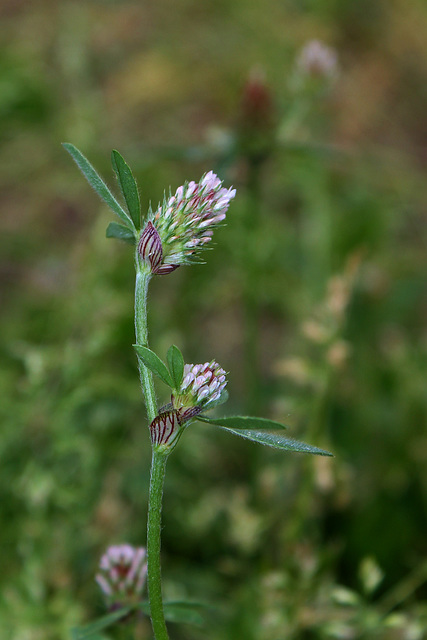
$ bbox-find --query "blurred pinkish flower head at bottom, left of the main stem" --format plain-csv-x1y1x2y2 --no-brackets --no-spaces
96,544,147,607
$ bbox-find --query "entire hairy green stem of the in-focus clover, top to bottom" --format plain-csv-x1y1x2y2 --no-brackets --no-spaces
135,256,169,640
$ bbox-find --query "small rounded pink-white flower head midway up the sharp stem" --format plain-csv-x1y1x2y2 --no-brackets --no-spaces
172,360,227,413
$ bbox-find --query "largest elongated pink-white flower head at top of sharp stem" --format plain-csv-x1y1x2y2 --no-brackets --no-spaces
138,171,236,274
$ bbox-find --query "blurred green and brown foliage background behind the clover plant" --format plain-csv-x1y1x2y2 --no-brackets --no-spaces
0,0,427,640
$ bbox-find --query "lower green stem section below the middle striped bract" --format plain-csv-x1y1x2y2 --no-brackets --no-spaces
147,447,169,640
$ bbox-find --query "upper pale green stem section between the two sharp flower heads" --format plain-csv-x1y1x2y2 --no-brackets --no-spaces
135,258,157,423
